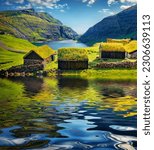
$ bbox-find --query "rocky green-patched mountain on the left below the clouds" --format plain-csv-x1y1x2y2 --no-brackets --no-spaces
0,9,78,41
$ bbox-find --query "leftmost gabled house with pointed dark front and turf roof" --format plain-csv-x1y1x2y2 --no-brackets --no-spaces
24,45,56,65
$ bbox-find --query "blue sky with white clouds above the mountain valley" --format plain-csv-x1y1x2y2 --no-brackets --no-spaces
0,0,136,34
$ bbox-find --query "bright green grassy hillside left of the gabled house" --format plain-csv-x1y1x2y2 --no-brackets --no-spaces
0,35,37,70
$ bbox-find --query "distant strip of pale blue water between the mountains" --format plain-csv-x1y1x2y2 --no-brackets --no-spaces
35,40,87,50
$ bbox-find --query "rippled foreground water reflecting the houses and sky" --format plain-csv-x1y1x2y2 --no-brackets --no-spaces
0,77,137,150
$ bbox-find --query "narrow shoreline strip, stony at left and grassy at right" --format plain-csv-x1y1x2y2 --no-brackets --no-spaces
0,69,137,81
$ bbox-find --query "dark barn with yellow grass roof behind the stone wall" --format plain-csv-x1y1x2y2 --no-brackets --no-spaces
99,43,125,59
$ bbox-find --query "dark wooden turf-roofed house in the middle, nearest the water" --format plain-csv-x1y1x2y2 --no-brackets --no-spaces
58,48,88,70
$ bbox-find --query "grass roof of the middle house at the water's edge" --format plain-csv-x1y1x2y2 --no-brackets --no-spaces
58,48,88,61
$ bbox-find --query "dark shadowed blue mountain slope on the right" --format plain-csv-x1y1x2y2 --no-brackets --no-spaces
79,5,137,45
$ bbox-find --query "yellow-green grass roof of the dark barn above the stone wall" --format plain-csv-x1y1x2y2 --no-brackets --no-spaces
99,43,125,52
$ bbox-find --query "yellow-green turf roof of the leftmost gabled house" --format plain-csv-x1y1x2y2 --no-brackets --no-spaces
25,45,55,59
